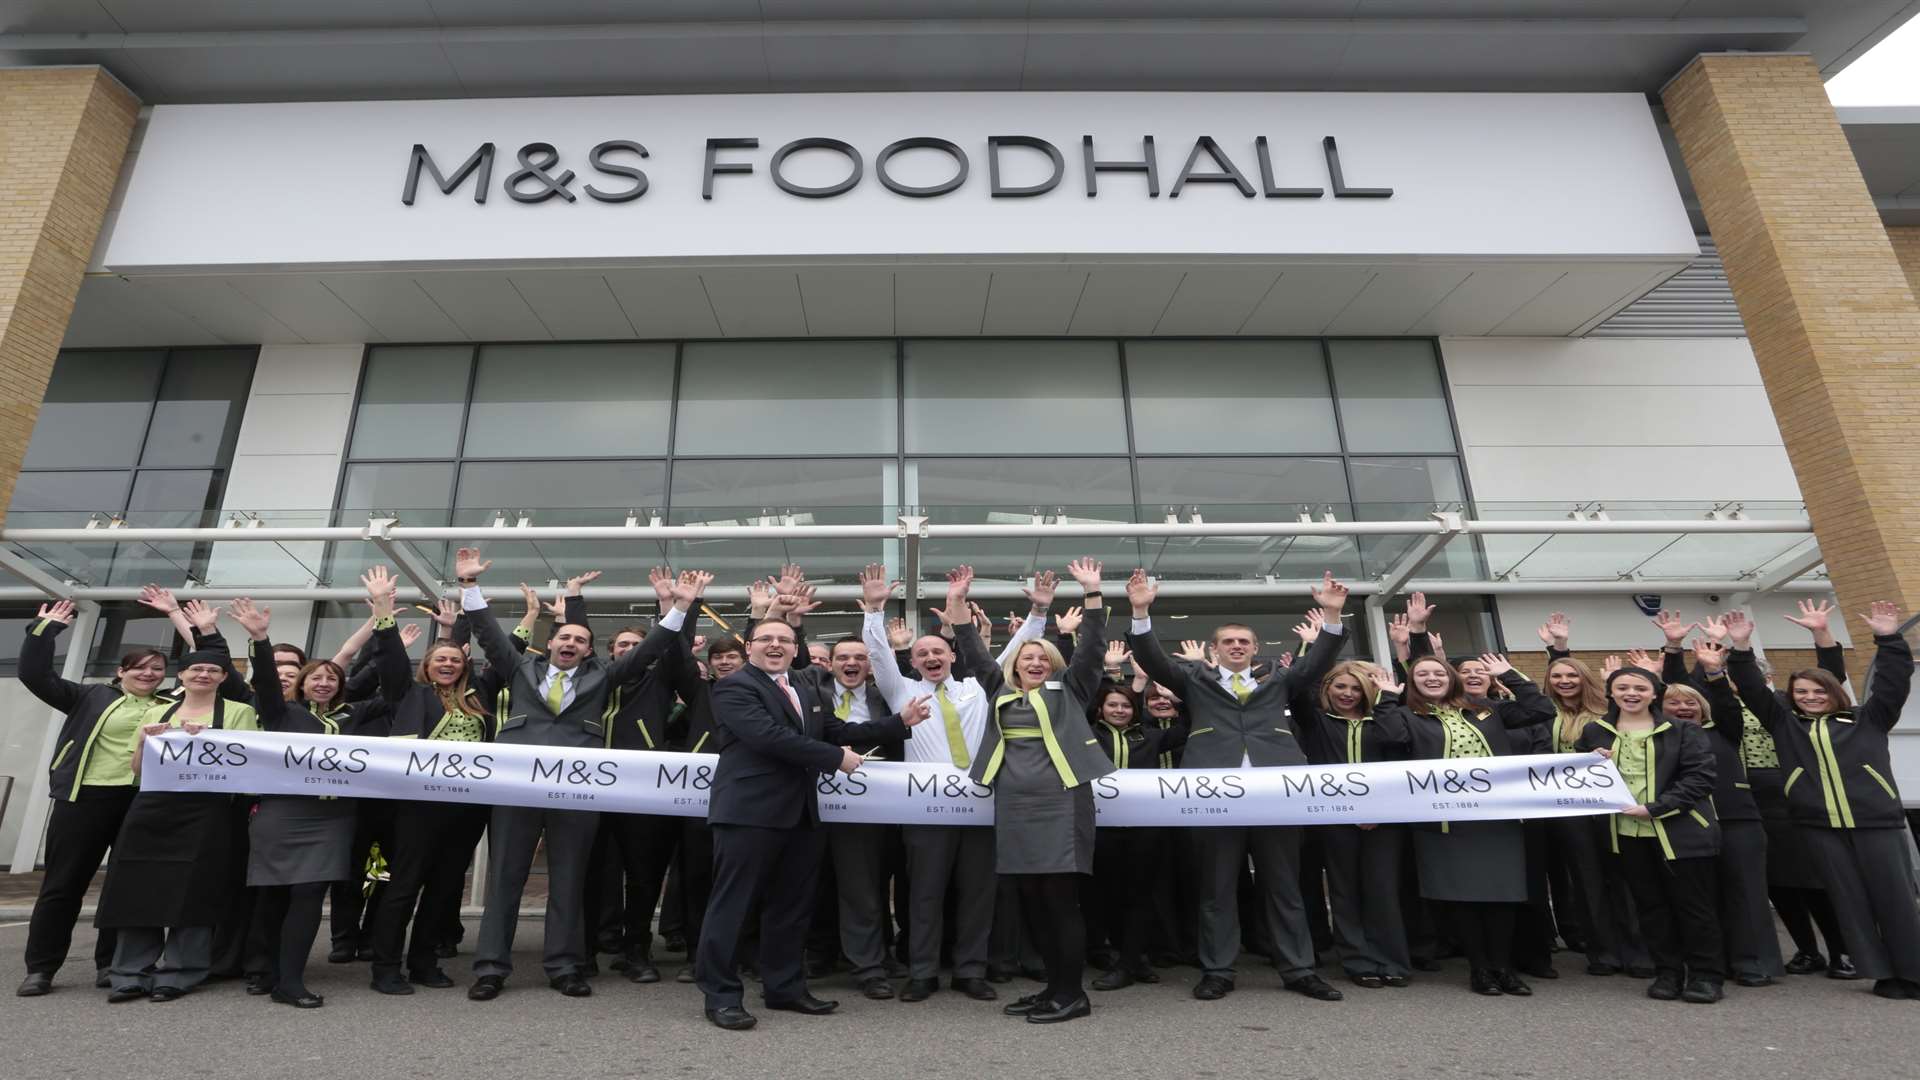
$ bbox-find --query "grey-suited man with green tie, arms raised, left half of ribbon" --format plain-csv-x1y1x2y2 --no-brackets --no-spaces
455,548,712,1001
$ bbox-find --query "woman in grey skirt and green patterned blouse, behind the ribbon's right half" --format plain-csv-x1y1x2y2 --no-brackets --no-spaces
1377,634,1553,997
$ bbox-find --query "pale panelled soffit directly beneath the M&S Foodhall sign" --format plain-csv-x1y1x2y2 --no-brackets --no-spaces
65,261,1684,348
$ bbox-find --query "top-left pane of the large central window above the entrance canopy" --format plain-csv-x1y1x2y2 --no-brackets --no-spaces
351,346,468,457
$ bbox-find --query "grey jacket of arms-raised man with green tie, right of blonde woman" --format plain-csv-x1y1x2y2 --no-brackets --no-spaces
1128,623,1346,769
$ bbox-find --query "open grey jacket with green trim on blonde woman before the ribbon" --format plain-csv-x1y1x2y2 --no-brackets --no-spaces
954,596,1116,788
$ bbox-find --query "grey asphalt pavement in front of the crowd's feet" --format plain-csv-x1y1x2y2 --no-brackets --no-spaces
0,919,1920,1080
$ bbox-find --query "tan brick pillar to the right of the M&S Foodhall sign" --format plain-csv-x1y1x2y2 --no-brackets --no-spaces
1663,54,1920,644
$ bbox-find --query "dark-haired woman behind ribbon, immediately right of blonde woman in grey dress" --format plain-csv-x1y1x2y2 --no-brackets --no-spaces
1087,676,1187,990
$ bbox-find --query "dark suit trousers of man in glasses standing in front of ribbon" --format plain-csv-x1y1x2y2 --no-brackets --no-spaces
693,824,826,1009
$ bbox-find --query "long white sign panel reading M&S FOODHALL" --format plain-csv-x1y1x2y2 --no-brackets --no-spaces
106,92,1697,273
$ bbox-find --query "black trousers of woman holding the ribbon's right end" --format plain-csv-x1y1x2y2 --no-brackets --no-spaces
1619,836,1726,982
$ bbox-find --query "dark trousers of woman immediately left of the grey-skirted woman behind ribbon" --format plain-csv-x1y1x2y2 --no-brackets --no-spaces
1317,824,1413,976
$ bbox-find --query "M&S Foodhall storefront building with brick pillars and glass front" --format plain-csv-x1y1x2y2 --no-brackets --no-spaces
0,0,1920,857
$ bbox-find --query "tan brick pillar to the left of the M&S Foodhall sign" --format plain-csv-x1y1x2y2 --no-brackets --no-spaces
0,67,140,523
